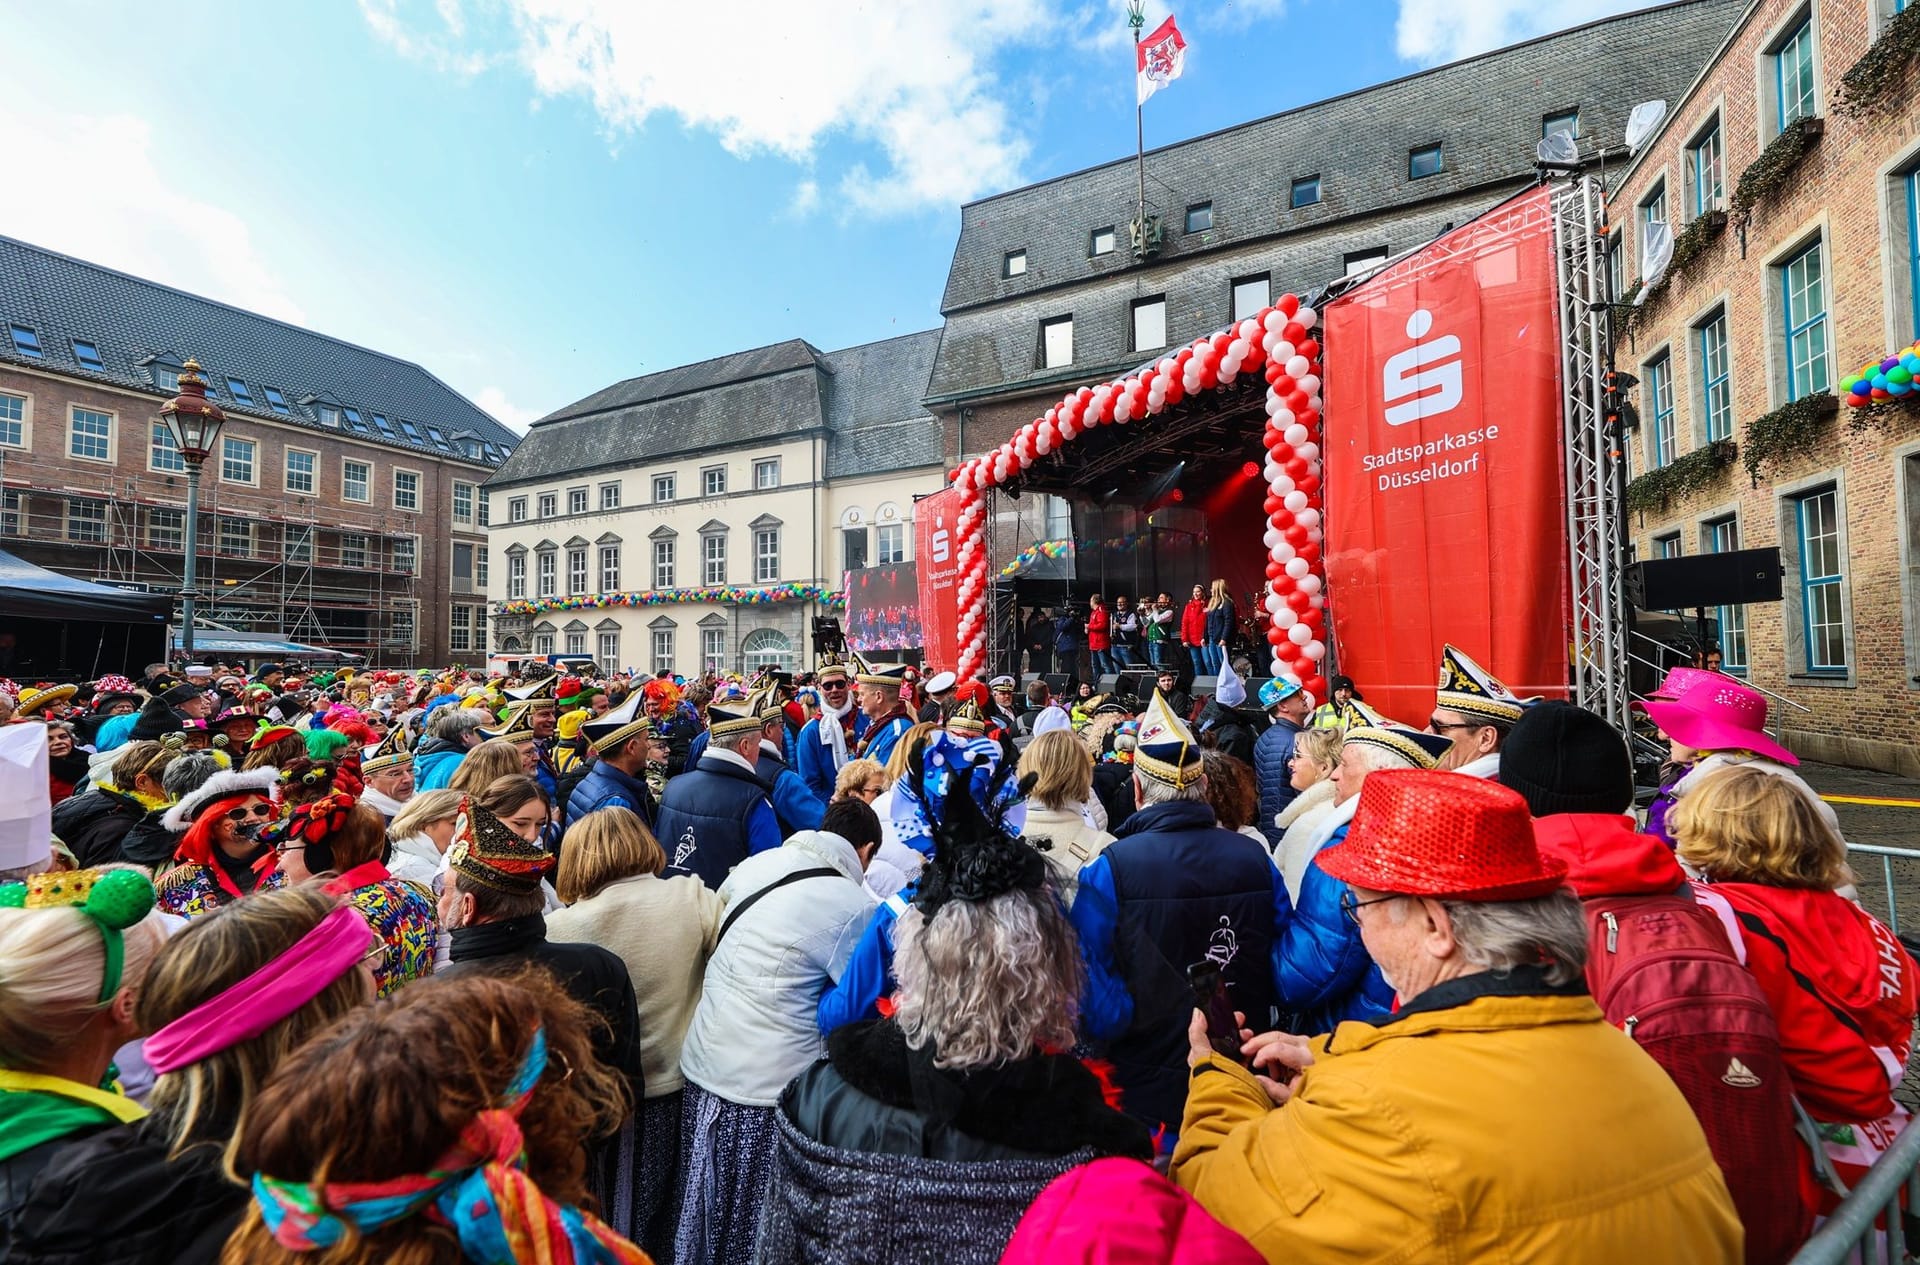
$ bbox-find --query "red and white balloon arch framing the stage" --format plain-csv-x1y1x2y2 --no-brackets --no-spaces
950,294,1327,699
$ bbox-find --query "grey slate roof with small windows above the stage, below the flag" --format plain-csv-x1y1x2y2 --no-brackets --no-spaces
927,0,1745,399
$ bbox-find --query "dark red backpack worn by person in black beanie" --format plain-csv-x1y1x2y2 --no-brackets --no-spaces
1582,895,1812,1265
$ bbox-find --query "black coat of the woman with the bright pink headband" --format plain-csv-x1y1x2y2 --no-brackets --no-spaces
0,1121,248,1265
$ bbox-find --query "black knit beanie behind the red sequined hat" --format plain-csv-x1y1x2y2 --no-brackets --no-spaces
1500,701,1634,818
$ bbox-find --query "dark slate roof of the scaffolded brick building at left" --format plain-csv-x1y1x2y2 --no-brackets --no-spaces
0,236,518,459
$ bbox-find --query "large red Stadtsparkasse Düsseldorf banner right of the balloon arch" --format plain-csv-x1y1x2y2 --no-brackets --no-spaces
1325,188,1572,728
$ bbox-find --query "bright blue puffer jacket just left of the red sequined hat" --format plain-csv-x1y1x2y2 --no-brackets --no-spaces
1273,823,1394,1035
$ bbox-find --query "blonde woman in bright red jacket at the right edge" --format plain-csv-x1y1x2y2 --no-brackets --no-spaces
1668,764,1920,1213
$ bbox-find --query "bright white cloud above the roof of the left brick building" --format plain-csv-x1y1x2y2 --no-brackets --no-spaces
0,96,305,328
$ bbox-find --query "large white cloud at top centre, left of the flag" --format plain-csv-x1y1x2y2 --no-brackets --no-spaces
361,0,1054,213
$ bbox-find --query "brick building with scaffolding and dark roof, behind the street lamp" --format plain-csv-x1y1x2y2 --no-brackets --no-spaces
0,238,516,664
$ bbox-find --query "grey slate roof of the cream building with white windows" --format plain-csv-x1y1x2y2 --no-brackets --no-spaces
490,330,941,488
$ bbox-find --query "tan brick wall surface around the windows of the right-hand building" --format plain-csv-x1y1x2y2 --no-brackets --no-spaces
1613,0,1920,774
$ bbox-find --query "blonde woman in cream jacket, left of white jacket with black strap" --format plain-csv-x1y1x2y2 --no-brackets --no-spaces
547,808,724,1259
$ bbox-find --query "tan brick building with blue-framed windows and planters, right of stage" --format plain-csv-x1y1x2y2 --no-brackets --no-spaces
1611,0,1920,776
